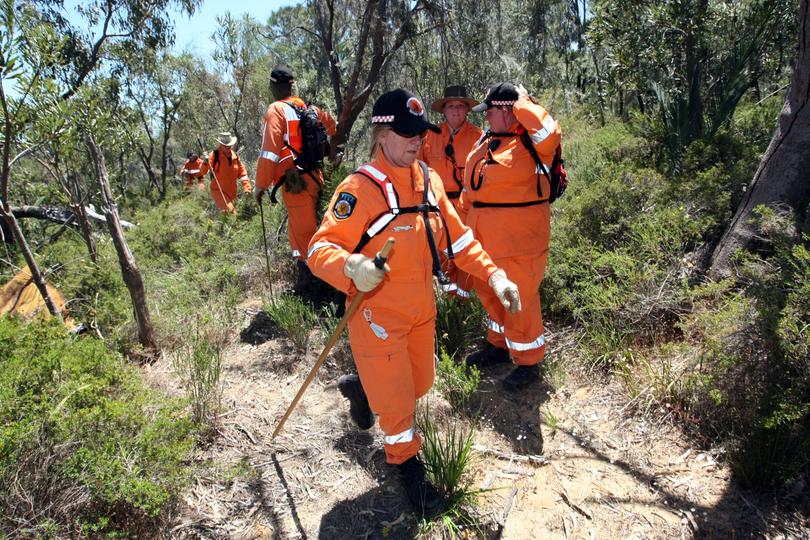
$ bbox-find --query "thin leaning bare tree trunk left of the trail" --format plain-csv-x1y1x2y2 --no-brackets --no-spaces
86,134,158,353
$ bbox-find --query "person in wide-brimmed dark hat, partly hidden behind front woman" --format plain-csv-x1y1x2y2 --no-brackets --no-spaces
420,86,481,298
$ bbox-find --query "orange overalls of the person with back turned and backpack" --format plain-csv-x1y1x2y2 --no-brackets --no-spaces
256,96,336,261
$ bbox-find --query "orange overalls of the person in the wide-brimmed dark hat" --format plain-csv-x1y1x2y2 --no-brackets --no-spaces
420,122,482,298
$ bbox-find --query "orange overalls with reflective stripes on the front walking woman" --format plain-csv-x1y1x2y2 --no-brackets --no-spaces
307,152,497,464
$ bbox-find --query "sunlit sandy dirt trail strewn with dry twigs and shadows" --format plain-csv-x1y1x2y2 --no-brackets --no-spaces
144,302,796,540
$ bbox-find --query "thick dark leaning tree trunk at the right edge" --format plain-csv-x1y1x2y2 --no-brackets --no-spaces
709,0,810,278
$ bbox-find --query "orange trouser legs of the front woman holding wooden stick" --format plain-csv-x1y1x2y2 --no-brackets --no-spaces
347,299,435,464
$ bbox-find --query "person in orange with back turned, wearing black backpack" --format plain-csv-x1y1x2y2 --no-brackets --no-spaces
256,65,336,294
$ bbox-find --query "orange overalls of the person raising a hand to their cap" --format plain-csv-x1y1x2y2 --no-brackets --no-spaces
461,98,561,365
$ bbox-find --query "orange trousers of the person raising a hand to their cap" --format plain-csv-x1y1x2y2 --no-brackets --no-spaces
475,252,548,366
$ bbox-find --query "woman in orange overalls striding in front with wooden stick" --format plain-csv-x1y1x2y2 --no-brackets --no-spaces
307,89,520,515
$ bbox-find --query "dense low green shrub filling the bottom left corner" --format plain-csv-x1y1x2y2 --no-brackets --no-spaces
0,318,193,536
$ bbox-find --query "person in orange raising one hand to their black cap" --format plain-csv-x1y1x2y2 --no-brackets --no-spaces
461,82,561,390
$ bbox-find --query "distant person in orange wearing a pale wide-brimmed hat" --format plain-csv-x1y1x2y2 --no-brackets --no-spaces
201,131,251,214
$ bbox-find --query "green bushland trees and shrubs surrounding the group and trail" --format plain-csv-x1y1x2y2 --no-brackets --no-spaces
0,0,810,537
